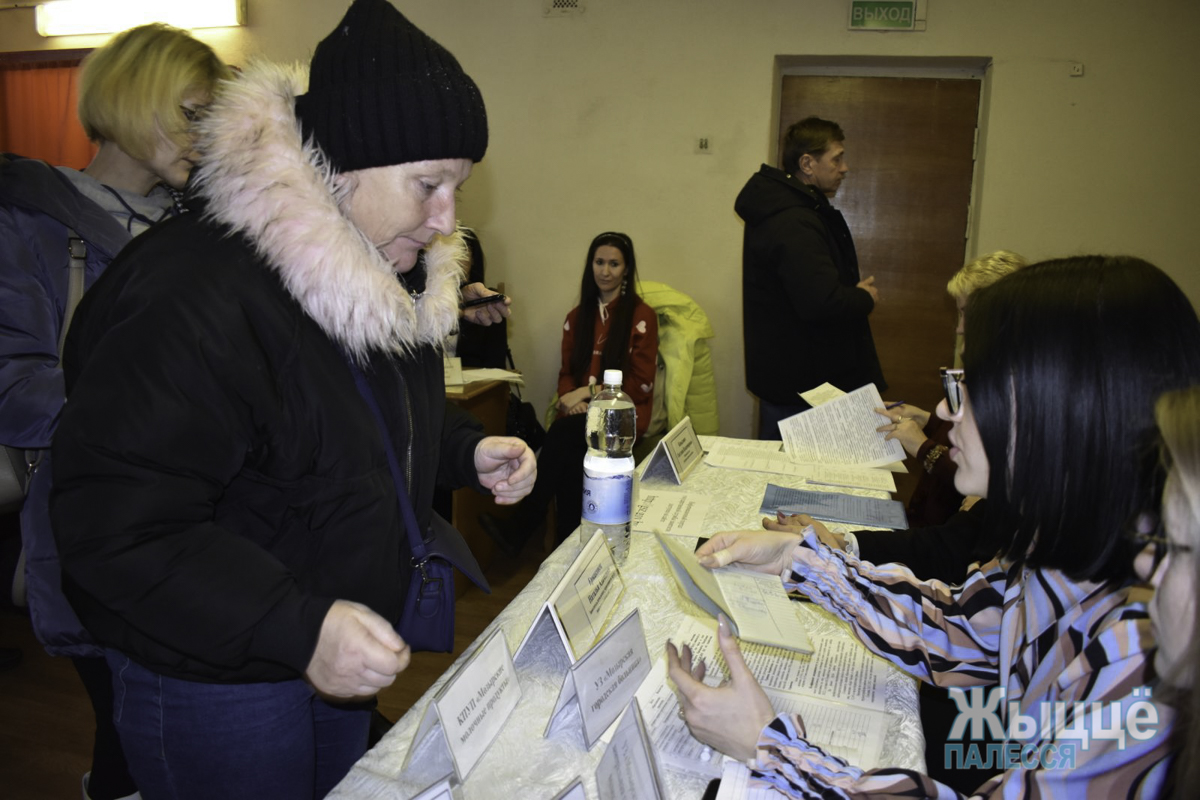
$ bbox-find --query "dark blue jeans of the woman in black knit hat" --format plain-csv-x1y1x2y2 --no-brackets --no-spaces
106,650,374,800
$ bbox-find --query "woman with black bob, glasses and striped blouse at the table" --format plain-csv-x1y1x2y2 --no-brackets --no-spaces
667,257,1200,798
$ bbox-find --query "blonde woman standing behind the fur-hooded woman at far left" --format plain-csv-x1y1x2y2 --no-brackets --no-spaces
0,24,230,800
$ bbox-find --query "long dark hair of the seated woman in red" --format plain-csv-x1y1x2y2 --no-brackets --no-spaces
570,231,641,386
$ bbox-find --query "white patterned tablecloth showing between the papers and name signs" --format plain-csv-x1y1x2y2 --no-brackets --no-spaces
329,437,924,800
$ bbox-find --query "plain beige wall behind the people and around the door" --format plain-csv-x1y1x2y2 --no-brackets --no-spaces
0,0,1200,435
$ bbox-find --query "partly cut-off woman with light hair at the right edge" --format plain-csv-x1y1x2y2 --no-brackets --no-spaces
1138,386,1200,796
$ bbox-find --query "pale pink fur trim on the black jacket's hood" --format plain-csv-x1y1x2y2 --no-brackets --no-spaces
196,62,466,360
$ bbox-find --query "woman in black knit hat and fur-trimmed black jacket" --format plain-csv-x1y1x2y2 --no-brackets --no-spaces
52,0,535,799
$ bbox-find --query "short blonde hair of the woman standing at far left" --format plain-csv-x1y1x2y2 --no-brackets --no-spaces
78,23,230,161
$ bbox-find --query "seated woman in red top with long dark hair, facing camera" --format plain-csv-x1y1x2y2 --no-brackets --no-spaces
480,231,659,557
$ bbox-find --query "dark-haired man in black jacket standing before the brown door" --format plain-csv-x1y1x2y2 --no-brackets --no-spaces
733,116,887,439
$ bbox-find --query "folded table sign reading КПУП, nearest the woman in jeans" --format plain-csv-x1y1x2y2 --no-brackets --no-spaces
401,628,521,782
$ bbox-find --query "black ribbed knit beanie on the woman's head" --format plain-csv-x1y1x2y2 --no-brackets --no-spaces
296,0,487,172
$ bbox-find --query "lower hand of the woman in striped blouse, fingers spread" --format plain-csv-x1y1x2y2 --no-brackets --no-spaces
667,615,775,760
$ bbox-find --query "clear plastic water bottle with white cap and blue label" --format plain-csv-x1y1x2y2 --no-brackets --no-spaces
580,369,637,563
